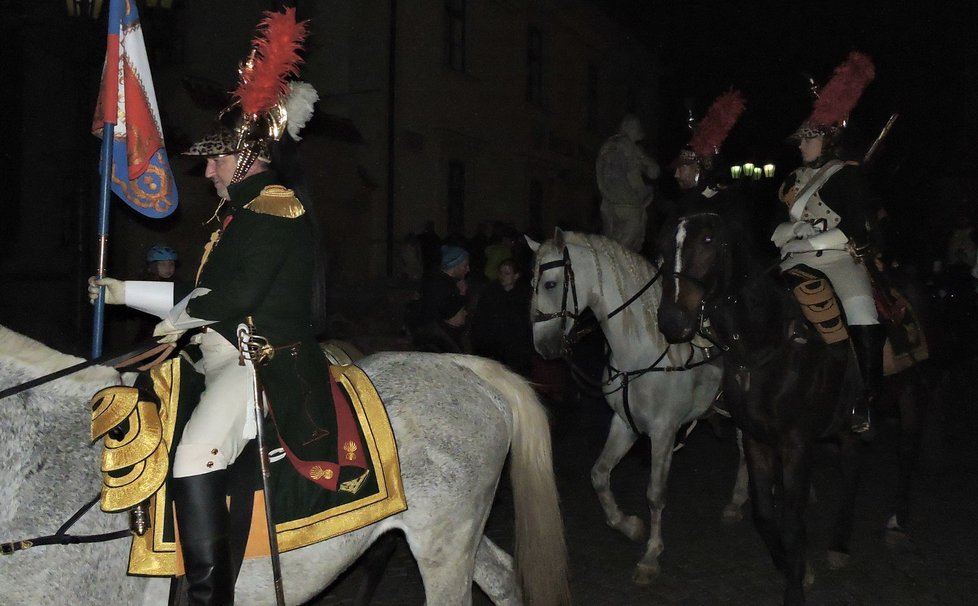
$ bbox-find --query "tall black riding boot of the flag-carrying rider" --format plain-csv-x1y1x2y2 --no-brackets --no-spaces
170,470,234,606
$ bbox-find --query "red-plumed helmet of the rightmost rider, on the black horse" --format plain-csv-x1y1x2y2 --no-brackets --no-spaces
790,51,876,139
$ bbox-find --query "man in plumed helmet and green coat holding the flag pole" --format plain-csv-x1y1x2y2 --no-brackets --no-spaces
90,9,345,605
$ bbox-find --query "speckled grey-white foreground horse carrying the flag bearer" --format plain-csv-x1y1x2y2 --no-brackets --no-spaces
0,326,569,606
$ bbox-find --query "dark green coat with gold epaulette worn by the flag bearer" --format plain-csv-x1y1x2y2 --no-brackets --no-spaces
187,172,340,490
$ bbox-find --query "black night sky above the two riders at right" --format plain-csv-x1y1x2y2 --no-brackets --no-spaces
598,0,978,204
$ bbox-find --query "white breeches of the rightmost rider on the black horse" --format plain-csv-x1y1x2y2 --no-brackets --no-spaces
781,250,879,326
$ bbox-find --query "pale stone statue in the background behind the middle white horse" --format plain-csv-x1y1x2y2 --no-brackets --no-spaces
595,114,659,252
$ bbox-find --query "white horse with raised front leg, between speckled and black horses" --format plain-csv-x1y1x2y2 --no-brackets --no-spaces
530,229,724,584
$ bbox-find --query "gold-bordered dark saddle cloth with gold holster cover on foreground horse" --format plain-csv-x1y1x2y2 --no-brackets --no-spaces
92,357,407,576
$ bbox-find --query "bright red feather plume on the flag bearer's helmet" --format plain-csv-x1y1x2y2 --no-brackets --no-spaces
232,8,309,115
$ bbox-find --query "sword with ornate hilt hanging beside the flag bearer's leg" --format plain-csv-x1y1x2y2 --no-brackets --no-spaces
238,316,285,606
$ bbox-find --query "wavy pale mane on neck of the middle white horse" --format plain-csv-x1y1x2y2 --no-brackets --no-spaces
564,232,661,335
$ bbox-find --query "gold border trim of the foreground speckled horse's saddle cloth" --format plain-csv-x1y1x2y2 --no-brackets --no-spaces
129,361,407,576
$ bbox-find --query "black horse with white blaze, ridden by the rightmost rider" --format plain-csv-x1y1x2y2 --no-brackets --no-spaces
658,202,932,604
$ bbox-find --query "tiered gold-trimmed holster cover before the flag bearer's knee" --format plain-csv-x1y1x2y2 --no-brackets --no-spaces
91,386,169,512
